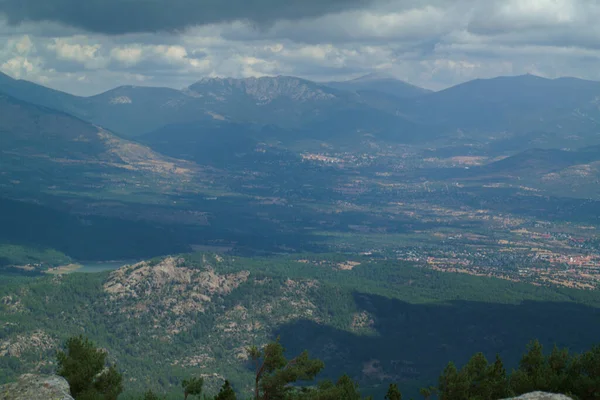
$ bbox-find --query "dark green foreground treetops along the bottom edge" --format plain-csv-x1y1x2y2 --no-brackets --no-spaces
57,336,600,400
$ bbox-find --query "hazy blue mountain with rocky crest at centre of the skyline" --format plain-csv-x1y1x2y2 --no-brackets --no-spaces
143,76,426,147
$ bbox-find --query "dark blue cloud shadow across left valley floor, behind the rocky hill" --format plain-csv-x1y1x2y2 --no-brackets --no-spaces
0,198,330,265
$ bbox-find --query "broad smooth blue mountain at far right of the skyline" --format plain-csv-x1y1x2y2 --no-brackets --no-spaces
404,75,600,133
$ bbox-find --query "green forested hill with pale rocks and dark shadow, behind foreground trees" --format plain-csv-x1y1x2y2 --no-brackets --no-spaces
0,253,600,396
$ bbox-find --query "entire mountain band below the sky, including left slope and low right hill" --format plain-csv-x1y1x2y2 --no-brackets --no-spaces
0,70,600,191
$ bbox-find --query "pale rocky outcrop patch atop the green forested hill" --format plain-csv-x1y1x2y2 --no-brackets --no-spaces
103,256,318,340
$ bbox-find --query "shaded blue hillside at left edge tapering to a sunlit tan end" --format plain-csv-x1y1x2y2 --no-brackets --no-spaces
0,94,196,196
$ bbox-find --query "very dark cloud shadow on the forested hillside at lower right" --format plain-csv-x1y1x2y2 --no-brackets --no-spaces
276,293,600,396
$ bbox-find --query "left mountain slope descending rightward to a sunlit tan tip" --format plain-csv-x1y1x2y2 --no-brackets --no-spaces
0,94,194,199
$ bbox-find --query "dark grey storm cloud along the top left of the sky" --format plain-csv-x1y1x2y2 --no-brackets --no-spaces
0,0,374,35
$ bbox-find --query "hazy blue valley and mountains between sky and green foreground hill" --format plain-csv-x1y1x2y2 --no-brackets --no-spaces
1,70,600,282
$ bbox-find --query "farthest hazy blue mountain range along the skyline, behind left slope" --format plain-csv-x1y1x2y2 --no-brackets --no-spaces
0,74,600,142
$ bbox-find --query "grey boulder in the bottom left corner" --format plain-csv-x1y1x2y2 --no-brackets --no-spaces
0,374,73,400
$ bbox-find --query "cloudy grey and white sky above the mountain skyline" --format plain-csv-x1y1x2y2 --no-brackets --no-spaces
0,0,600,95
